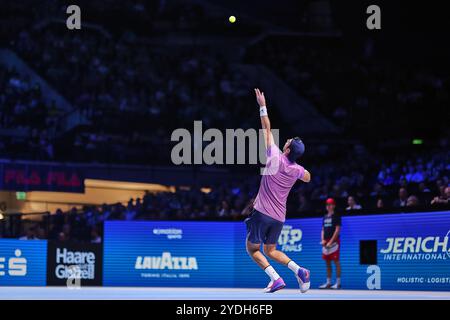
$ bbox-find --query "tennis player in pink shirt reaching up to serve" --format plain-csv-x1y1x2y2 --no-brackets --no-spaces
245,89,311,293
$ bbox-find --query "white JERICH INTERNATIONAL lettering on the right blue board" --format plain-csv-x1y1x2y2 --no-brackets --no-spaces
380,230,450,261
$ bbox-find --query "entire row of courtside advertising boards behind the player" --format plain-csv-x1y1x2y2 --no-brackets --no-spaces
0,212,450,291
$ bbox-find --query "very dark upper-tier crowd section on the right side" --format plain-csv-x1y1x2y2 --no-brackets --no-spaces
246,36,450,137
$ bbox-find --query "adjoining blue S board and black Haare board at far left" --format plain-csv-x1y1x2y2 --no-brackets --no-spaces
0,239,103,286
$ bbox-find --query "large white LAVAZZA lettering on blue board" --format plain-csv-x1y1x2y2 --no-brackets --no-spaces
135,252,198,270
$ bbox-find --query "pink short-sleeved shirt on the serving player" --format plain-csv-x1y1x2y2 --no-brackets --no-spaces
254,144,305,222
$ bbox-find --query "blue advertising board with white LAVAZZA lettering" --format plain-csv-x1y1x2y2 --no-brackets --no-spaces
103,221,235,287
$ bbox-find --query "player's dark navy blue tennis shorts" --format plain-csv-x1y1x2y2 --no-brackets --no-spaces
245,209,283,244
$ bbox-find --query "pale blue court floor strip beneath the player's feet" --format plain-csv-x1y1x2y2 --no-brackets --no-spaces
0,287,450,300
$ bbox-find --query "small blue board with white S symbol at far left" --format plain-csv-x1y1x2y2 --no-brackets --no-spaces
0,239,47,286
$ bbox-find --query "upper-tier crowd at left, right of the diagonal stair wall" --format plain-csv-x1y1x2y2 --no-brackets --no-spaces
9,25,268,164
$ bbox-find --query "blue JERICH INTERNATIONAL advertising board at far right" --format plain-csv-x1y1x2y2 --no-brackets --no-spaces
341,212,450,291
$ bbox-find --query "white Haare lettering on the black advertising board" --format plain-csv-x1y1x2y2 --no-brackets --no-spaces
55,248,95,280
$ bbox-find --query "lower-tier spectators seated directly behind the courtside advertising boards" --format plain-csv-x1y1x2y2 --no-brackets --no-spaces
12,146,450,242
